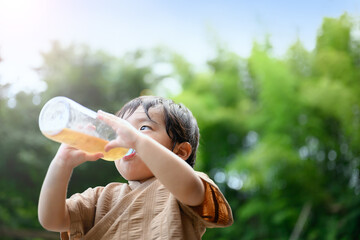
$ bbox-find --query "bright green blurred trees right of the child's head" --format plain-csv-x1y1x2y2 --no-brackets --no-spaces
177,14,360,239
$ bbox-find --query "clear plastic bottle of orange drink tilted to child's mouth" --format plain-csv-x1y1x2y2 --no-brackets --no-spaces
39,97,129,161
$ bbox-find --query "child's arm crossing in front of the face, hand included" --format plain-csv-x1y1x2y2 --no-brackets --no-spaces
98,111,205,206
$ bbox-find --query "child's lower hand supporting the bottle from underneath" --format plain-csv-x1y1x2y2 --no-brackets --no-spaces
54,144,104,169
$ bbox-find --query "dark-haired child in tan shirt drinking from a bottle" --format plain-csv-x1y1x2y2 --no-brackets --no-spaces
38,96,233,240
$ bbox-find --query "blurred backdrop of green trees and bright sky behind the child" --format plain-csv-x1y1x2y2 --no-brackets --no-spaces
0,0,360,240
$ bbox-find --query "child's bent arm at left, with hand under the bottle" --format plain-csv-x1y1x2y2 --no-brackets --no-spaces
38,144,103,232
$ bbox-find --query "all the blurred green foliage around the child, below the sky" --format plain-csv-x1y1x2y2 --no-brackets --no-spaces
0,14,360,240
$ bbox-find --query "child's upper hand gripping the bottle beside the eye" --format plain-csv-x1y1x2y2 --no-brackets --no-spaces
98,110,141,151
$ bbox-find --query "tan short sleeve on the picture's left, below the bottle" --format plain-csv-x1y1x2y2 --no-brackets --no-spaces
60,187,103,240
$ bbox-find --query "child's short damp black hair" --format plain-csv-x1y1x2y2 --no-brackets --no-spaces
116,96,200,167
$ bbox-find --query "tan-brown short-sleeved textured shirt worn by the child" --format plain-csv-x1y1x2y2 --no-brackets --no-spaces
61,173,233,240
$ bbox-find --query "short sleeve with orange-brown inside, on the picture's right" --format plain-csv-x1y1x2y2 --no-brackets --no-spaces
180,172,234,227
